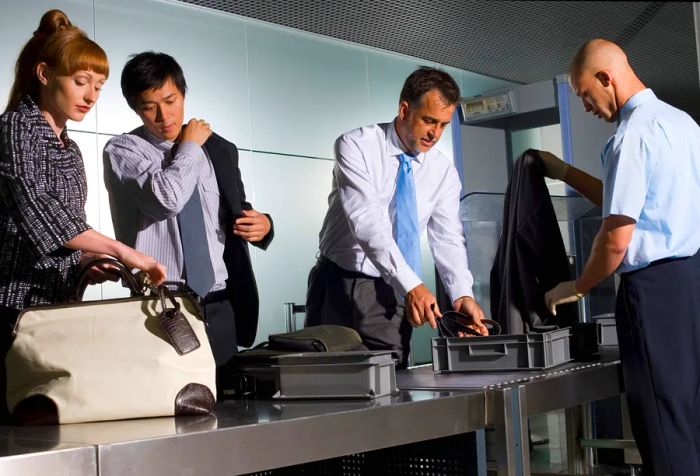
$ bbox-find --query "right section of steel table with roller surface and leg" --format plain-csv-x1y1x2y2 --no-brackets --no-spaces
397,349,624,475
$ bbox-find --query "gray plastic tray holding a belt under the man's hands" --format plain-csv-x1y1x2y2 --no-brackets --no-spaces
432,327,572,373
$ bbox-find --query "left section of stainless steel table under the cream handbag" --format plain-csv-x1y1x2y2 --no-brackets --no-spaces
0,390,486,476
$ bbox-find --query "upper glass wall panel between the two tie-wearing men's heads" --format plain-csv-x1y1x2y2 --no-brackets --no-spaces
248,23,368,159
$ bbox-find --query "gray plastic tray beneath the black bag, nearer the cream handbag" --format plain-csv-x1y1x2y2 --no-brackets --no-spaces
224,351,397,399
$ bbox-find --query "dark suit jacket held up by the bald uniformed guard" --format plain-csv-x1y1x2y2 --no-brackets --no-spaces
490,150,578,334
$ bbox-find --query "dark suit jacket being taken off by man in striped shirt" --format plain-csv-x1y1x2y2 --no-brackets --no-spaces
204,134,274,347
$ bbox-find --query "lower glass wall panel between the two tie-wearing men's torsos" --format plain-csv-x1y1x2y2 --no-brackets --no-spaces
246,153,333,341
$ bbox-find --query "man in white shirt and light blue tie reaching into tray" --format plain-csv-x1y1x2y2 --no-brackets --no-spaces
306,67,487,366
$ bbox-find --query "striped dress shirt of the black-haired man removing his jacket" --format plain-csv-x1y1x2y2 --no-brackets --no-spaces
103,126,227,291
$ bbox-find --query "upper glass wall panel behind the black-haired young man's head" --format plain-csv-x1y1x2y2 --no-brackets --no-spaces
95,0,250,148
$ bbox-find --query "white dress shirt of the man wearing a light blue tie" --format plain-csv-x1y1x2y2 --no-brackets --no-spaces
319,122,473,301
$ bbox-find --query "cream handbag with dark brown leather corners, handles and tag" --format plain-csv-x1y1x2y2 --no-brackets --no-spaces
5,260,216,424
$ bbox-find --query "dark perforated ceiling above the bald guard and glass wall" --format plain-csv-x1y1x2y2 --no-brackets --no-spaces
182,0,700,120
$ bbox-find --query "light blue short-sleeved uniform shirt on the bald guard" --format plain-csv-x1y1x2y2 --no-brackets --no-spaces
602,89,700,272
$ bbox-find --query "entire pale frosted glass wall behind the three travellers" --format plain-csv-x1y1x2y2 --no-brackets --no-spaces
0,0,516,352
